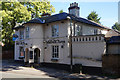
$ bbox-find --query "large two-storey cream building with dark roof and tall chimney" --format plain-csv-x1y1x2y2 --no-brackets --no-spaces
14,2,110,71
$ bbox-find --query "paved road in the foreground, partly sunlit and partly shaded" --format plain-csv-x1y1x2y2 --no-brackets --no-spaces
0,60,120,80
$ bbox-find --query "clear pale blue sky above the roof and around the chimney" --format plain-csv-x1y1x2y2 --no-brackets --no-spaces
50,0,118,28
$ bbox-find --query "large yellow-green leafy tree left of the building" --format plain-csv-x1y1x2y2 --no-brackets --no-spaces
1,0,55,49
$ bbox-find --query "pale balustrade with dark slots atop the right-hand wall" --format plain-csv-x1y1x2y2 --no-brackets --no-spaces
72,35,104,42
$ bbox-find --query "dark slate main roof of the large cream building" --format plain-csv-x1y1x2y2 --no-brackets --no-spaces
14,12,108,29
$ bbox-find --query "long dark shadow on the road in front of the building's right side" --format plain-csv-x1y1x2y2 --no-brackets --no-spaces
35,67,109,80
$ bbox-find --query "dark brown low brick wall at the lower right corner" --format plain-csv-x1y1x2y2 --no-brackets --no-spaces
102,54,120,76
